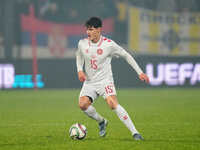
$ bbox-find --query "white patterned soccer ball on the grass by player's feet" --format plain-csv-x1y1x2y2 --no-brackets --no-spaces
69,123,87,140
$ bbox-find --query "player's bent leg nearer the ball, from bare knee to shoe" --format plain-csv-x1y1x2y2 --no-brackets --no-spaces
79,96,107,137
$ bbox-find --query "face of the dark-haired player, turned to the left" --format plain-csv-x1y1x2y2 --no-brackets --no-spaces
86,27,101,43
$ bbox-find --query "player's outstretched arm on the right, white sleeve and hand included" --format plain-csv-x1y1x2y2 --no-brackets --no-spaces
112,42,149,83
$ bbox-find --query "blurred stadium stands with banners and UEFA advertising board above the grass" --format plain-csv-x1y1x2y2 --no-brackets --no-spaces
0,0,200,89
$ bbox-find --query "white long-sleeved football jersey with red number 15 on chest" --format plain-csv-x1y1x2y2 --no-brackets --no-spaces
76,36,142,83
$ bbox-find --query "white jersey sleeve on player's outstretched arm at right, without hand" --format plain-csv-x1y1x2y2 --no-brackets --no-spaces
111,41,143,75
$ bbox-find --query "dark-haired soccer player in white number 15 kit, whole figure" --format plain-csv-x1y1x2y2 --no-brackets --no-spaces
76,17,149,140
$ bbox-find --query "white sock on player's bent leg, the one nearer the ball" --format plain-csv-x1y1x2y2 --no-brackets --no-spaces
84,105,103,123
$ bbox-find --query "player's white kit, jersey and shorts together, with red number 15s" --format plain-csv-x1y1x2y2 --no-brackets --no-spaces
76,36,142,100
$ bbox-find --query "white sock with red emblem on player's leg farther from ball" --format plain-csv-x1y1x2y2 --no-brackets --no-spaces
114,104,138,135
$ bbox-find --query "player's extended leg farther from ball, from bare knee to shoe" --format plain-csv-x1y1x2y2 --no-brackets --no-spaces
106,95,143,140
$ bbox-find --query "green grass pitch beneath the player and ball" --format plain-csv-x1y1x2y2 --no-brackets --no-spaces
0,88,200,150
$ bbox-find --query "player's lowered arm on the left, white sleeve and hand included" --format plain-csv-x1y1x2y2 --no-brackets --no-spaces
76,42,86,82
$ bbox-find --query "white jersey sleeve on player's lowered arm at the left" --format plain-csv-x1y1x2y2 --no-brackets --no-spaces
76,41,84,72
